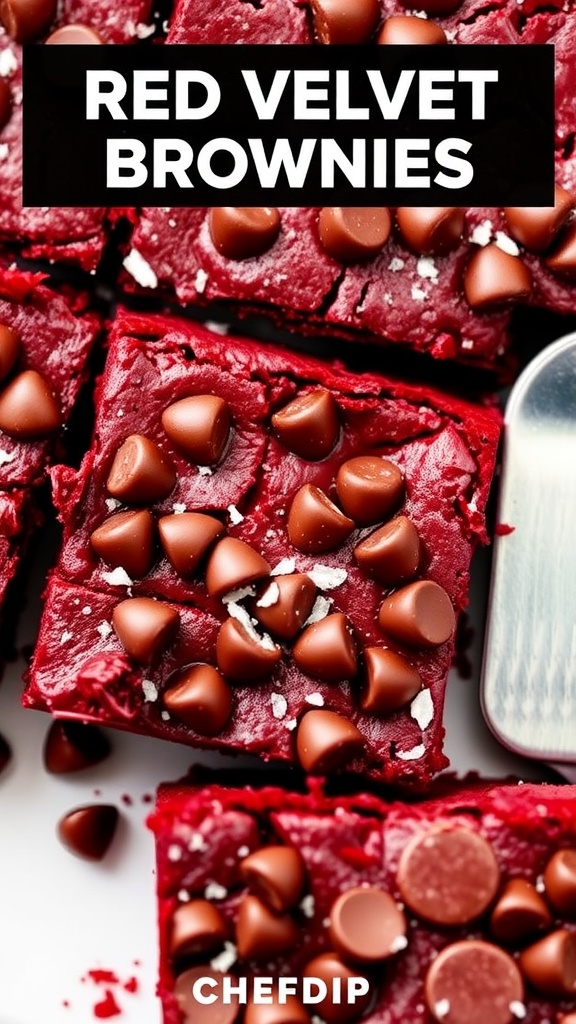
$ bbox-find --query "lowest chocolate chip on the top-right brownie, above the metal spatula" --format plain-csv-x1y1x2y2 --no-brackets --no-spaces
463,244,532,309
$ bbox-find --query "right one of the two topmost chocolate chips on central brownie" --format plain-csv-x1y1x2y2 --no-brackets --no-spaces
272,390,340,462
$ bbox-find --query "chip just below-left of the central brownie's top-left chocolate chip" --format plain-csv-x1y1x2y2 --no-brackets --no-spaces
106,434,176,504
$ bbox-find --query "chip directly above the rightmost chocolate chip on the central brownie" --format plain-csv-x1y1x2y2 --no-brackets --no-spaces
354,515,422,587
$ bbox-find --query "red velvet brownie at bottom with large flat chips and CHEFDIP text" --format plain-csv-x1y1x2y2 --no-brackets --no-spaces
150,784,576,1024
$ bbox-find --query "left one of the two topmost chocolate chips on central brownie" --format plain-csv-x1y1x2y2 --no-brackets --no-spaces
162,394,231,466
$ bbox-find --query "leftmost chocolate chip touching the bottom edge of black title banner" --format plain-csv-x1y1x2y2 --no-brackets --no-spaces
208,206,280,259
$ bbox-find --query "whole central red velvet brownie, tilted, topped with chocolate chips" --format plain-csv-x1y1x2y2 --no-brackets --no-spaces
26,313,499,781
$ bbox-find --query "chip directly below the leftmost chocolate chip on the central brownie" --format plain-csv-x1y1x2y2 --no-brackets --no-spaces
112,597,180,665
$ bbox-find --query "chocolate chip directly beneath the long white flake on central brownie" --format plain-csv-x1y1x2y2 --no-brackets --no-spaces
216,618,282,683
